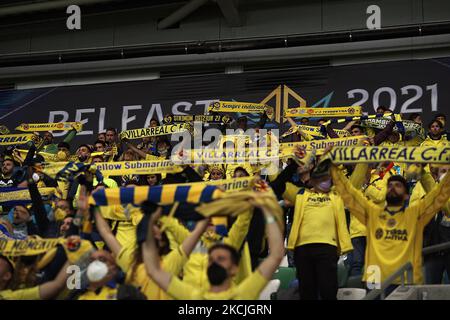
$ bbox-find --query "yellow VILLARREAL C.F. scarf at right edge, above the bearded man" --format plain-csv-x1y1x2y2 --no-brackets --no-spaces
324,146,450,164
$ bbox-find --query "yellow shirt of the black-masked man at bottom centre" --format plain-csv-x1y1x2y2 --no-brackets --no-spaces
167,270,269,300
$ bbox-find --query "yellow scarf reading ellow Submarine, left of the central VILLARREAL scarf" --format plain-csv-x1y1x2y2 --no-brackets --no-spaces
92,160,183,176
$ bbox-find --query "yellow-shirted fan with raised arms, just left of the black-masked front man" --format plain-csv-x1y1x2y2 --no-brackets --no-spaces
95,201,208,300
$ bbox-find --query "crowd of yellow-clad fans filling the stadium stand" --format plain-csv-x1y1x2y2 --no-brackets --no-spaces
0,108,450,300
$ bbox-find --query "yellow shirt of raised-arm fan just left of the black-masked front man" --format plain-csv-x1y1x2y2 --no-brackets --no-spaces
116,242,187,300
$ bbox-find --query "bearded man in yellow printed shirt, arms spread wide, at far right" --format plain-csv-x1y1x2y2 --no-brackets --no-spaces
331,162,450,294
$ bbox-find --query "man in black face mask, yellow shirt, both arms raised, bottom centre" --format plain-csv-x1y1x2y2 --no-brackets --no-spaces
143,196,284,300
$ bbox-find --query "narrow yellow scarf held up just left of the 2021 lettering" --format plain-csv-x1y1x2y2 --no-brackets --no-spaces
284,106,362,118
